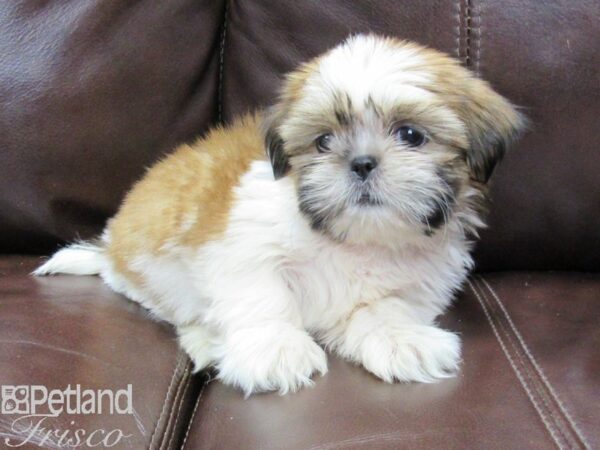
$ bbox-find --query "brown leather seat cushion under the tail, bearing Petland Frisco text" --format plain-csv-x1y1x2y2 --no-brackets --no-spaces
0,256,201,448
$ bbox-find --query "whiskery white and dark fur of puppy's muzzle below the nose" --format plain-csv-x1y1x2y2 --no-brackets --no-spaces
299,160,483,245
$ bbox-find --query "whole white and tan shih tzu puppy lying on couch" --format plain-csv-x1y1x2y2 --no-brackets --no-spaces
34,35,523,394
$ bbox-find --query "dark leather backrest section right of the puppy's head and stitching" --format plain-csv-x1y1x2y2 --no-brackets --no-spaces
471,0,600,271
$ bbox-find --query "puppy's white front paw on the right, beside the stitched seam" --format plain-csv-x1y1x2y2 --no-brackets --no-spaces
355,325,460,383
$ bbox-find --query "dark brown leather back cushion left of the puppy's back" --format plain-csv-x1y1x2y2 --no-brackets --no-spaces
0,0,223,253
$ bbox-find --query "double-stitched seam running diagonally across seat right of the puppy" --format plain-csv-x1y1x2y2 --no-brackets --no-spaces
478,276,590,449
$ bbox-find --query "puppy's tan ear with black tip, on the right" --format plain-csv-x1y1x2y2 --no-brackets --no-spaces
461,79,526,183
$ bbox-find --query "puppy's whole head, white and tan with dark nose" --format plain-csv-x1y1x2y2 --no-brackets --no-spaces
264,35,523,246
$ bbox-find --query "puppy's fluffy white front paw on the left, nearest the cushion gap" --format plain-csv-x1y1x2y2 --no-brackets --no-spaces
217,324,327,396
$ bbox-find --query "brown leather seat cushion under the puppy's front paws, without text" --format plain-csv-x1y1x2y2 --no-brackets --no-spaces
186,273,600,449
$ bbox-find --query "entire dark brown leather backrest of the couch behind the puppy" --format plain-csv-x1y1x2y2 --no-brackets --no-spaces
0,0,600,270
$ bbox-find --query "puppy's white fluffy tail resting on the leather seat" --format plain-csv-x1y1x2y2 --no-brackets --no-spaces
32,242,106,276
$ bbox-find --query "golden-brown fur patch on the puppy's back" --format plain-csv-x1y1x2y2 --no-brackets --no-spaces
107,116,265,281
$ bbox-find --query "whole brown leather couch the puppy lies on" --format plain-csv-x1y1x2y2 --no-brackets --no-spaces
0,0,600,449
